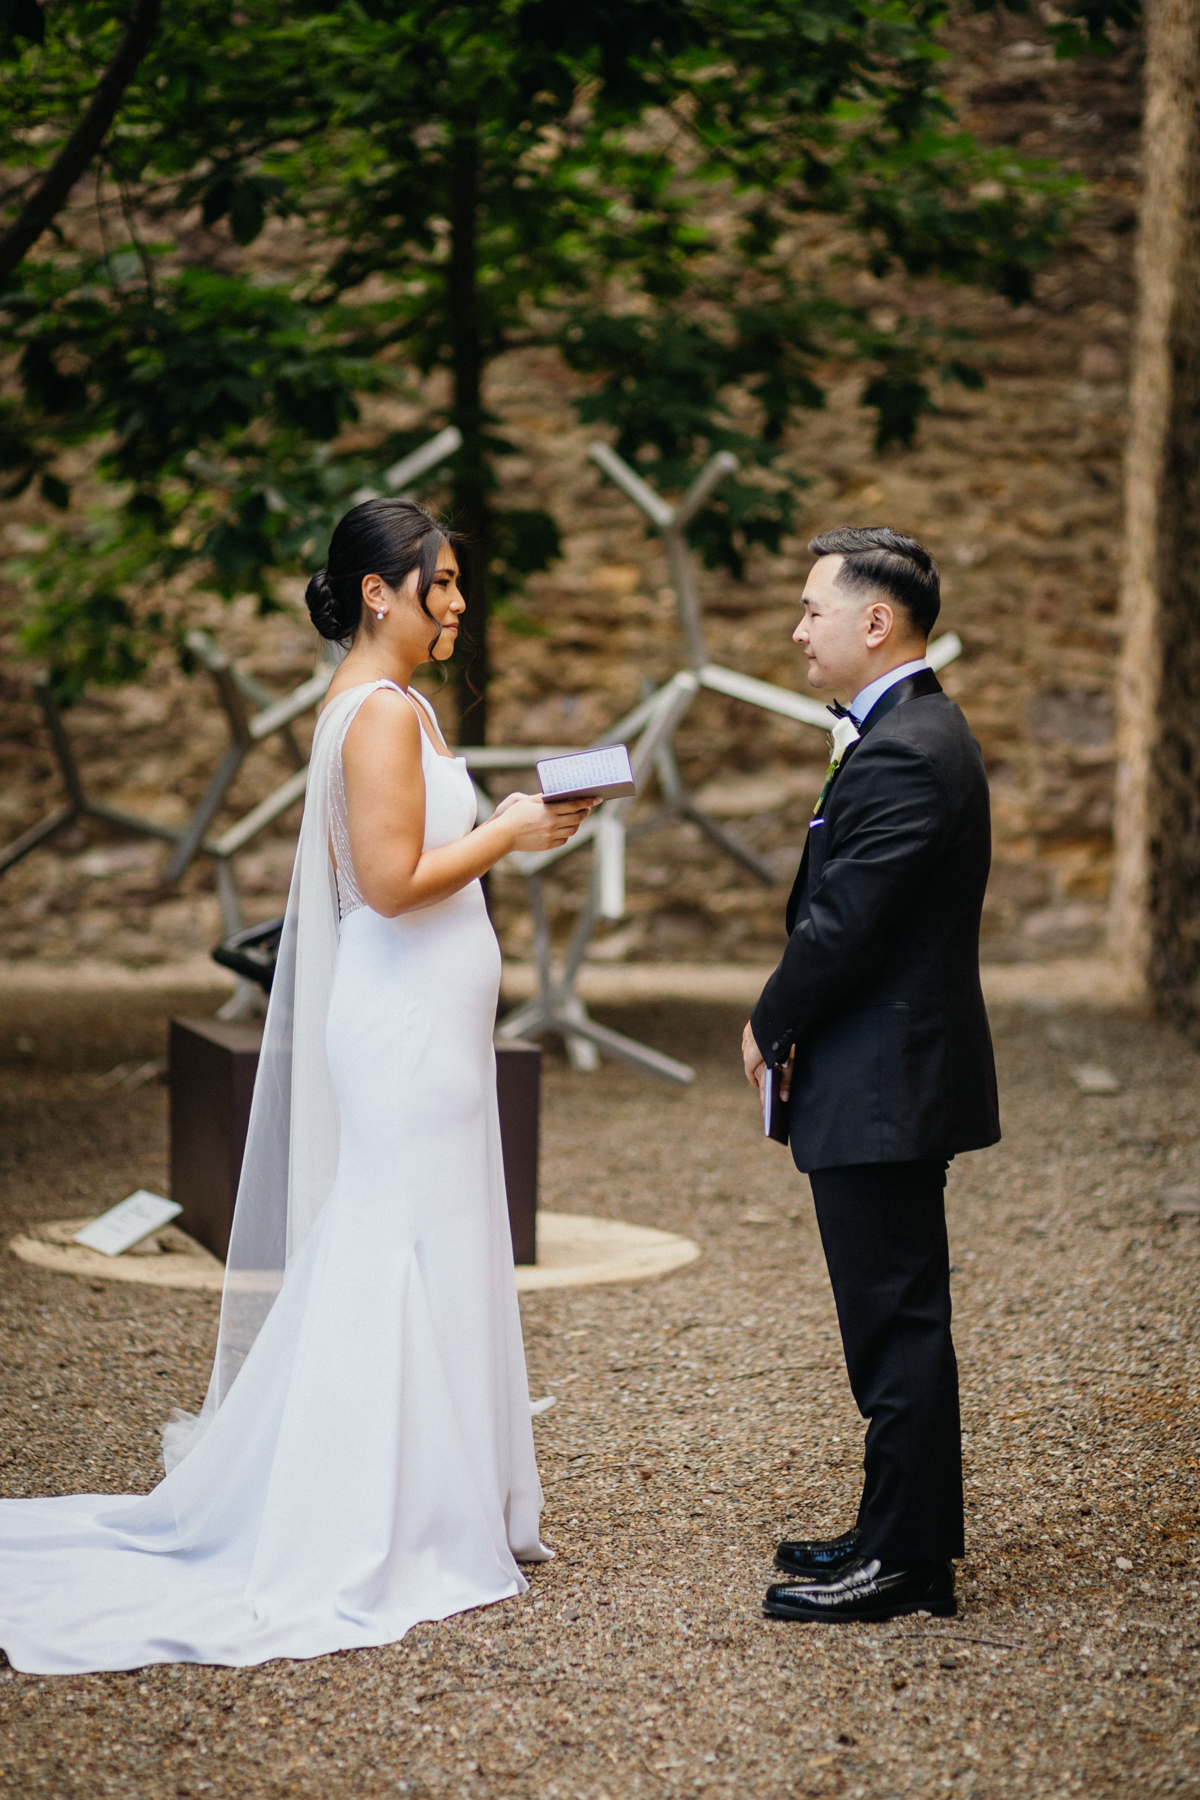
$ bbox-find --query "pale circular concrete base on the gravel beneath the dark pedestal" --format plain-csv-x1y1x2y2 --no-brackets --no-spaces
9,1213,700,1294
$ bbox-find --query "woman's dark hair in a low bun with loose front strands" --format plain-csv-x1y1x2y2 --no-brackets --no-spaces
304,499,459,655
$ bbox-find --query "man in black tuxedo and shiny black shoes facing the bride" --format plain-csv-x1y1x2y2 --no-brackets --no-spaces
743,526,1000,1622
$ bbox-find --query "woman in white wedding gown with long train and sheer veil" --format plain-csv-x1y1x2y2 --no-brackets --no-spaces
0,499,587,1674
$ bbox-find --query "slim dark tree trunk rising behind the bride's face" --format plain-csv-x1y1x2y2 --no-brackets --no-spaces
446,119,491,743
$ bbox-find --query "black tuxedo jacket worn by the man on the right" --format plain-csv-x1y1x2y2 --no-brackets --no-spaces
750,670,1000,1170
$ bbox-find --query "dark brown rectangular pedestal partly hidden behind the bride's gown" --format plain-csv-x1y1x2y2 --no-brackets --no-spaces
171,1019,542,1264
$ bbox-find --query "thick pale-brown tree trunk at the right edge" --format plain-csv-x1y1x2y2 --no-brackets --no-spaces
1110,0,1200,1040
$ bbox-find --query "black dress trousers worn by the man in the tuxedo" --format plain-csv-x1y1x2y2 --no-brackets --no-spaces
808,1161,963,1564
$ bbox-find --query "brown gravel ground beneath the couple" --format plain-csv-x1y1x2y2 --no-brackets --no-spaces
0,1008,1200,1800
